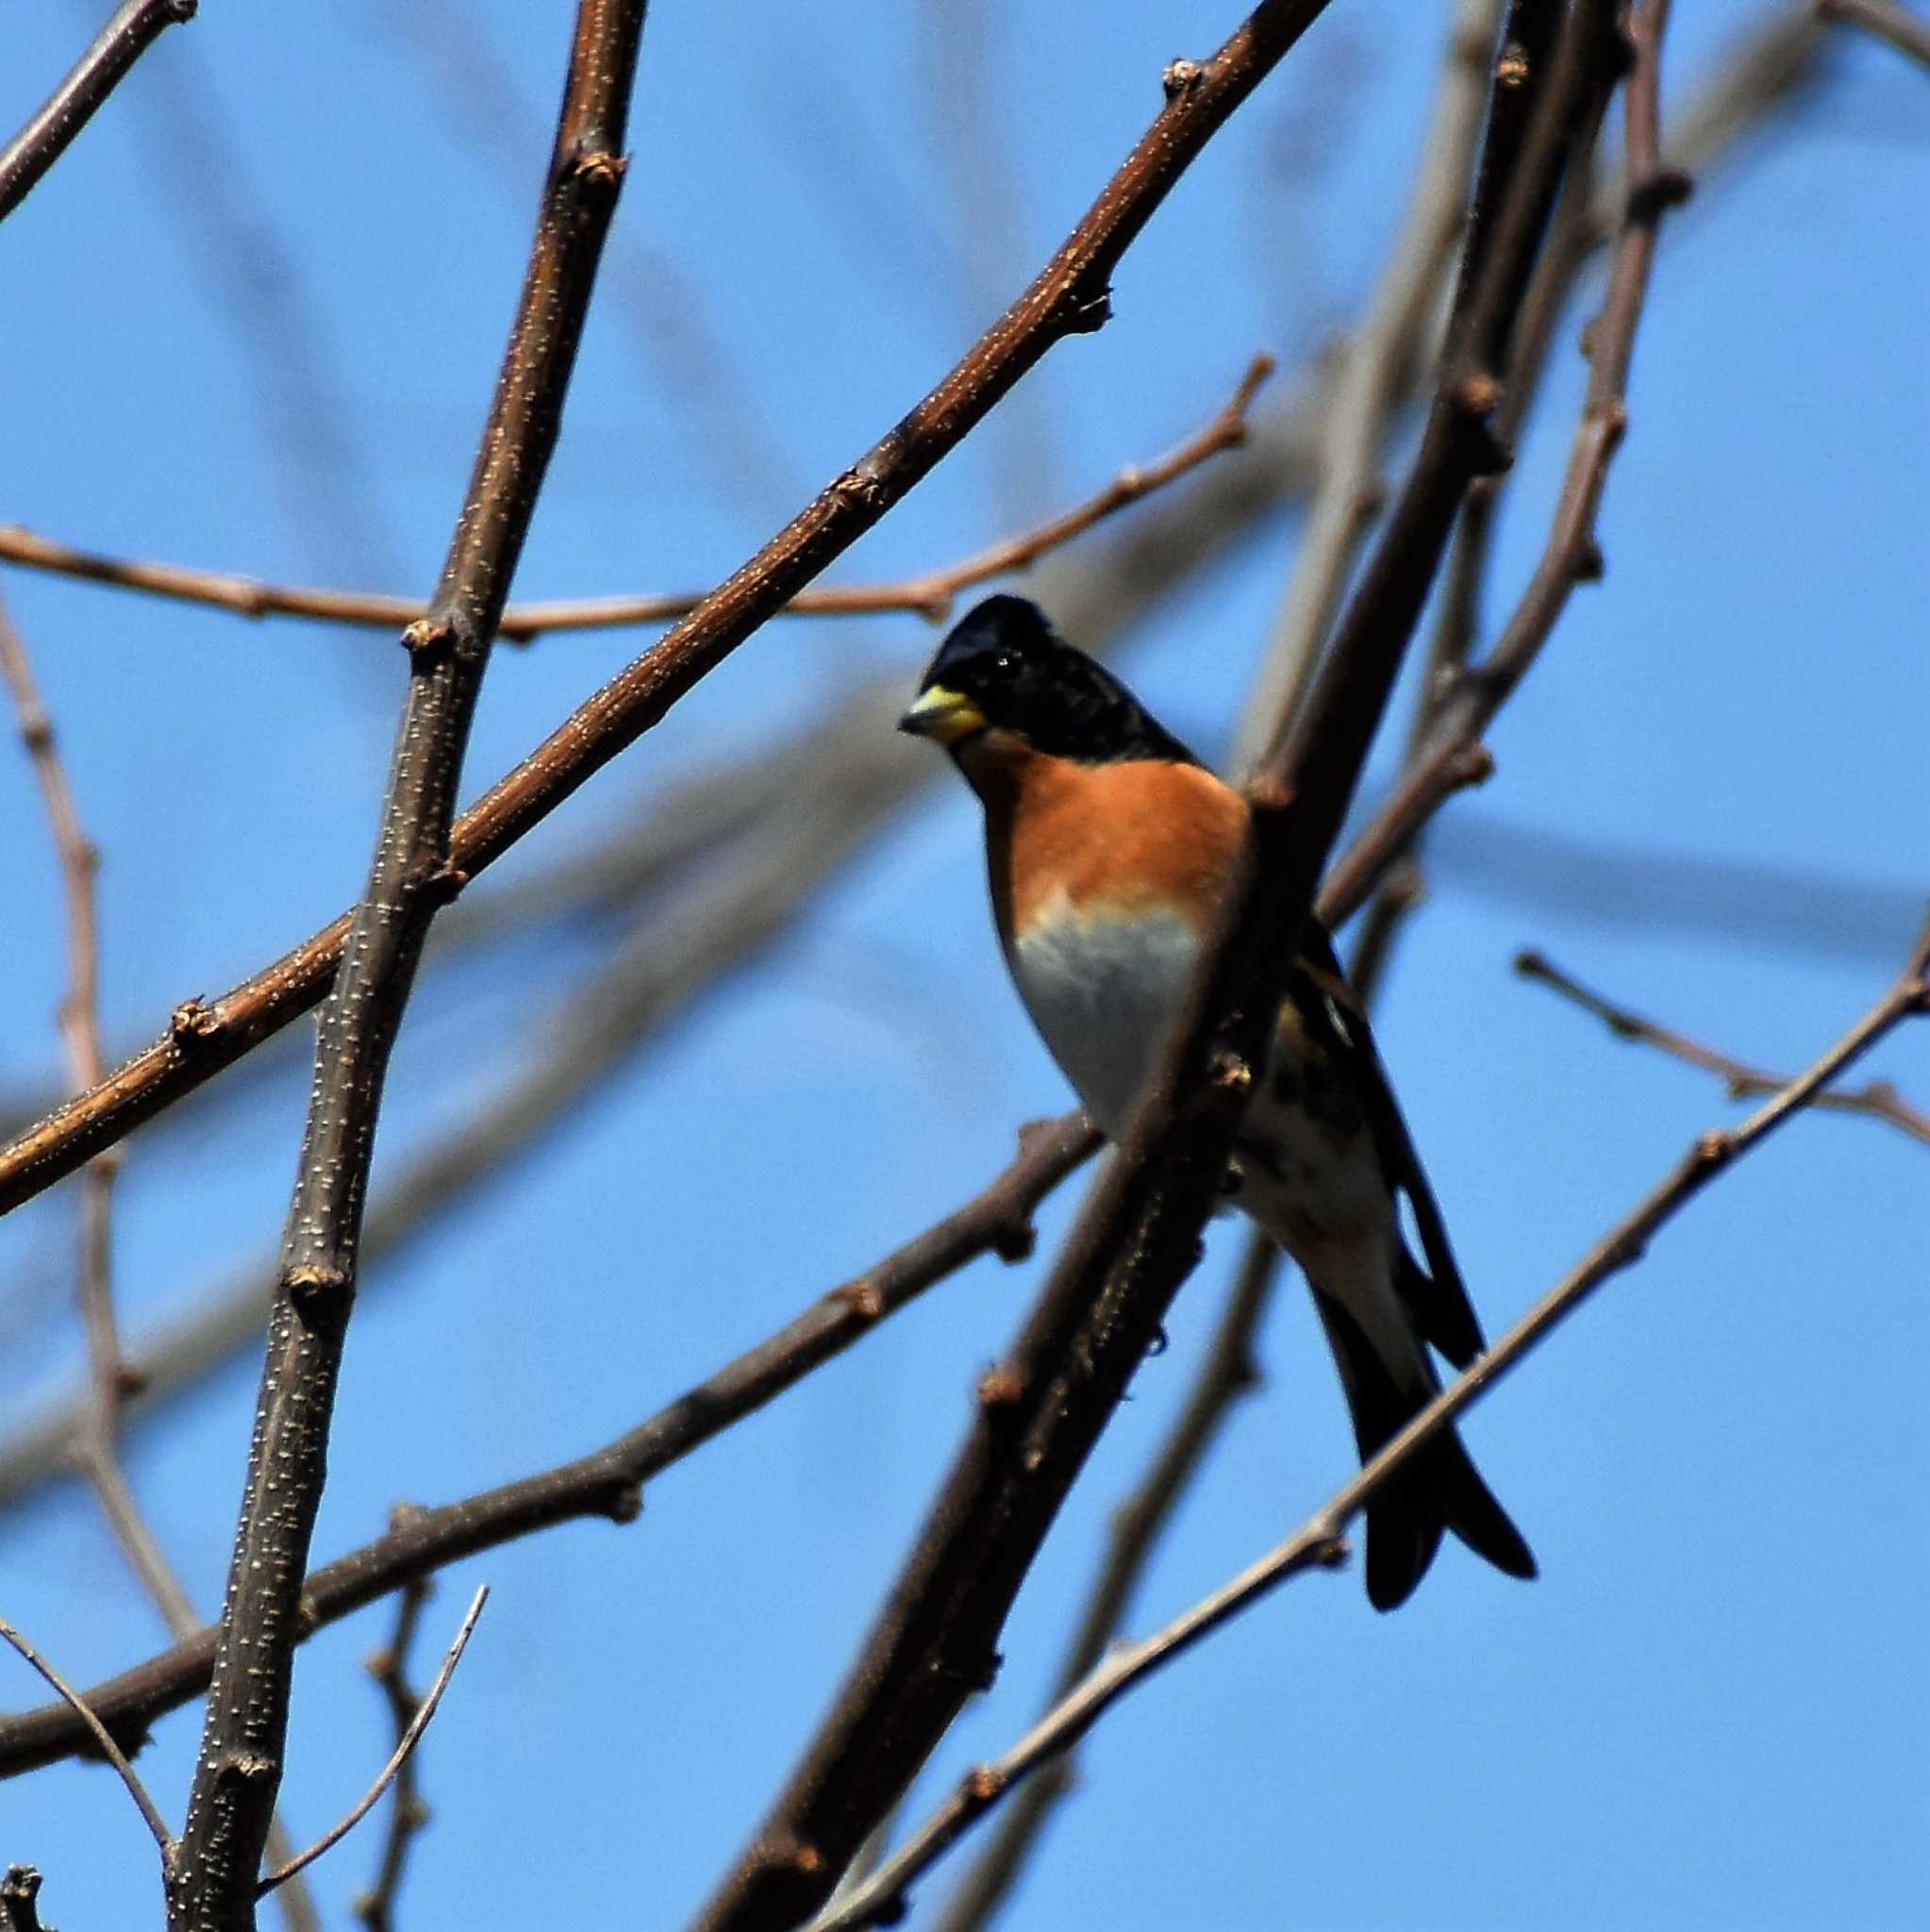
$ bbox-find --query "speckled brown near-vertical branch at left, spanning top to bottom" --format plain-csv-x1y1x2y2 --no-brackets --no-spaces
168,0,645,1932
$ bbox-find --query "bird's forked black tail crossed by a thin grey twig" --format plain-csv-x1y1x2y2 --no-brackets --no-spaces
1314,1287,1536,1609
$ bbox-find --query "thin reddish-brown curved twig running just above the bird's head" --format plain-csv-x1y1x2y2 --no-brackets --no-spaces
0,356,1273,643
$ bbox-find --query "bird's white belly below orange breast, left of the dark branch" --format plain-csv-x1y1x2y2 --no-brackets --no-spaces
1012,900,1200,1140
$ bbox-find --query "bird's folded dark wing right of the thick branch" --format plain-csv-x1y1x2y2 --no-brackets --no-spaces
1287,920,1484,1368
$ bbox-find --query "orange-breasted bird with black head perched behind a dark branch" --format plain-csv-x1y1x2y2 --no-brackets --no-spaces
898,595,1536,1611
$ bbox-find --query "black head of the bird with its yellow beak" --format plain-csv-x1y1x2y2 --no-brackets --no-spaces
898,597,1198,765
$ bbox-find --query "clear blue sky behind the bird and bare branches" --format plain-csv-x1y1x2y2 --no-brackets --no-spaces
0,0,1930,1932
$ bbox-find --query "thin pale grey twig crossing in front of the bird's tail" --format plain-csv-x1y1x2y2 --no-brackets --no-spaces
809,900,1930,1932
